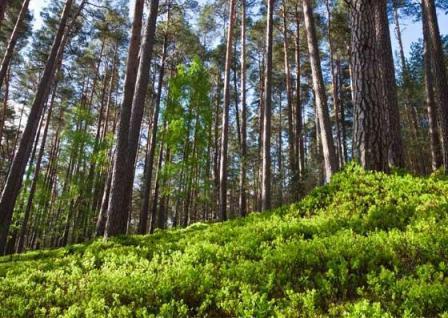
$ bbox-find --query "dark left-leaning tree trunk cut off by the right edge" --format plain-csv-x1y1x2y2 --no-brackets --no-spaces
422,0,448,171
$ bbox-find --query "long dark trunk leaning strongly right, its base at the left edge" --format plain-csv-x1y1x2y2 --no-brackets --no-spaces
0,0,73,254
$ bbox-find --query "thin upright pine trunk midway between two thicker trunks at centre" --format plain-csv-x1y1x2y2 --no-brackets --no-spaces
239,0,247,216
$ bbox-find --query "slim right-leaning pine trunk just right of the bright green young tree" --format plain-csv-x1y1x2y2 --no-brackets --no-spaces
219,0,236,221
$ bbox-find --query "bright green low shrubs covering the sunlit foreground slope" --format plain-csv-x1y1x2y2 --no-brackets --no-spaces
0,166,448,317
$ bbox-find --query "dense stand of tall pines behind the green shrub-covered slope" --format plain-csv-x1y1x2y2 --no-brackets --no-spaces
0,0,448,253
